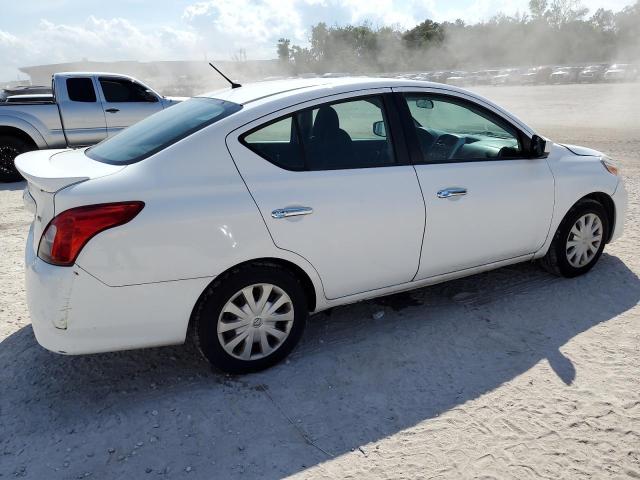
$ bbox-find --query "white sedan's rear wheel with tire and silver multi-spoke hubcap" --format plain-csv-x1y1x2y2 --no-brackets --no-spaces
193,264,309,374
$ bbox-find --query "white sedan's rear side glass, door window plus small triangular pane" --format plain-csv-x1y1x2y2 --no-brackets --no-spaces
241,97,395,171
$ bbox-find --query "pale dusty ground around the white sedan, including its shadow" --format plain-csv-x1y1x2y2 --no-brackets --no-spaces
0,85,640,479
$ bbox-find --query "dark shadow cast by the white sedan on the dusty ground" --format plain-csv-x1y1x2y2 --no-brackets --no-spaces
0,255,640,479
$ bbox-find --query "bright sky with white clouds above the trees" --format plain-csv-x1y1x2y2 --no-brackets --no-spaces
0,0,632,81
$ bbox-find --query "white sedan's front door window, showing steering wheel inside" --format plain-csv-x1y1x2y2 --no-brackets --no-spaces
404,94,522,162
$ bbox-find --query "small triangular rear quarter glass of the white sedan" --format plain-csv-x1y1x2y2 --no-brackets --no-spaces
244,117,304,170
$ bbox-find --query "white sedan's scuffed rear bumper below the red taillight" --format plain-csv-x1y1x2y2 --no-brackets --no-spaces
25,227,211,354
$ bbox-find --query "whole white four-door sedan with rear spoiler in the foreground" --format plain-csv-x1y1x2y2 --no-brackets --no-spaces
16,78,626,373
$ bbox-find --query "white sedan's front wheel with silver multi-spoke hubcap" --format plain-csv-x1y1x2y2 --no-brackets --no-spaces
542,199,609,278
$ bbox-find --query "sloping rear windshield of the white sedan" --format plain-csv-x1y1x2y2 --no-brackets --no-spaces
86,97,242,165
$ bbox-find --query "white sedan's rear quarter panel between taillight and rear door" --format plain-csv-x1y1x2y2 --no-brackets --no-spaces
55,124,321,304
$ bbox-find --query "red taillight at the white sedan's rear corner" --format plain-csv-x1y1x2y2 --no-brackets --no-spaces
38,202,144,267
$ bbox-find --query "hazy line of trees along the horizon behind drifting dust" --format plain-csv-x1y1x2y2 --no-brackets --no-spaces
277,0,640,74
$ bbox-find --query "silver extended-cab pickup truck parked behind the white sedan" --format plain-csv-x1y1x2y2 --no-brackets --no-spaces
0,72,183,182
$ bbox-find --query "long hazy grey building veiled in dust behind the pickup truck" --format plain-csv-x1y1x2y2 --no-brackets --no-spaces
20,60,279,96
